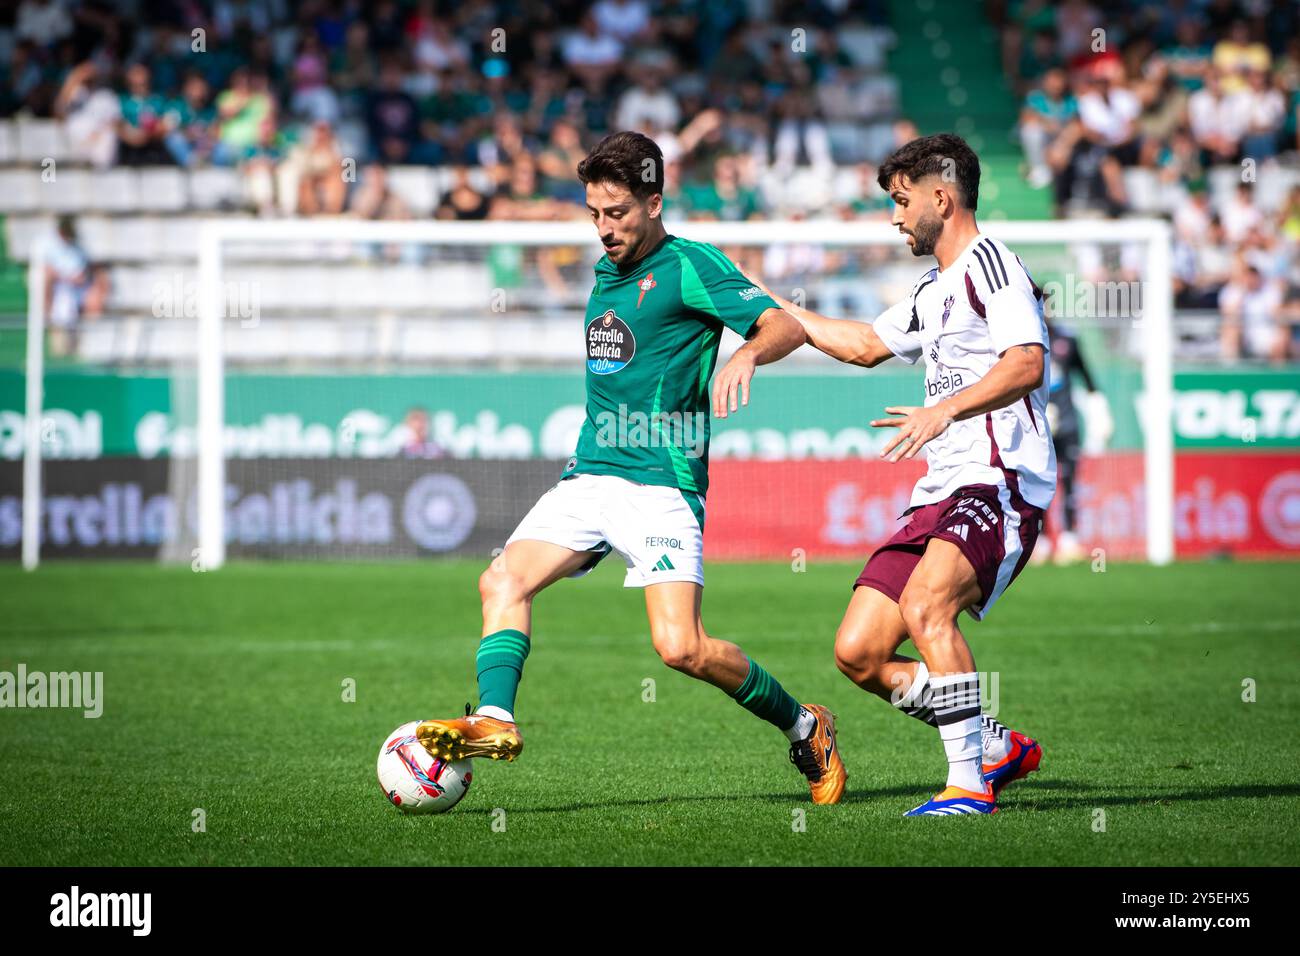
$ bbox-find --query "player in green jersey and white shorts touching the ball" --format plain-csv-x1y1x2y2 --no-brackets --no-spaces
417,133,845,804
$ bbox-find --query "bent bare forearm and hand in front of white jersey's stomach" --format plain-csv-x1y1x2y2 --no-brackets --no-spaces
871,343,1045,462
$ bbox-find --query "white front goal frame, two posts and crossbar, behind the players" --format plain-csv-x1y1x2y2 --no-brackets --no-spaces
195,219,1174,570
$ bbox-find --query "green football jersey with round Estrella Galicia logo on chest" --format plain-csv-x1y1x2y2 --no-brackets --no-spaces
563,235,777,496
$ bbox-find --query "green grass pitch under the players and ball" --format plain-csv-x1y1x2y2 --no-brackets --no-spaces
0,559,1300,866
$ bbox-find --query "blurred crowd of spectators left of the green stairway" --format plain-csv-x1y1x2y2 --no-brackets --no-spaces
0,0,892,219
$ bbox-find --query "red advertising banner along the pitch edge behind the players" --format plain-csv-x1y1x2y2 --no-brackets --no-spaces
705,451,1300,559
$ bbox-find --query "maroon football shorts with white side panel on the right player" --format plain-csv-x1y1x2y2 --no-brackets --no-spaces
853,485,1043,620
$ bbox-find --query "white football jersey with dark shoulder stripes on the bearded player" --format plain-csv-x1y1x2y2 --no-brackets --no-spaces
874,235,1056,510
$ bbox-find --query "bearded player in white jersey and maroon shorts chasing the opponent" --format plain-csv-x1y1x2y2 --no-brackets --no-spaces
759,134,1056,816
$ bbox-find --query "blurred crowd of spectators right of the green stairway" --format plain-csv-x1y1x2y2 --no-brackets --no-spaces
995,0,1300,362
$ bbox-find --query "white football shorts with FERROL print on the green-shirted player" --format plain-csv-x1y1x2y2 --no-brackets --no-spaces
506,475,705,588
